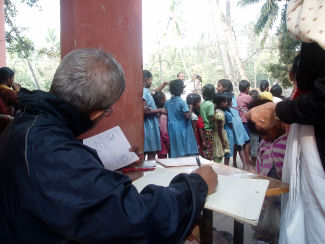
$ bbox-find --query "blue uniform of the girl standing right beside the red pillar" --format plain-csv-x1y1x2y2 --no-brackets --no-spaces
143,88,161,152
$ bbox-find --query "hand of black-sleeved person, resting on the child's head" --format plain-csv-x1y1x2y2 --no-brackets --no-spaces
246,102,278,130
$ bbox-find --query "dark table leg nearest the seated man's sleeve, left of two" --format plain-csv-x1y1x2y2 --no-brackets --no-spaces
200,209,213,244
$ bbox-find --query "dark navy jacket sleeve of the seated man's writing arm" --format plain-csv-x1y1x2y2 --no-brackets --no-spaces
31,140,208,243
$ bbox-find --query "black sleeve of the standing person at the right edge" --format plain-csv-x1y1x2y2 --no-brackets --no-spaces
276,78,325,125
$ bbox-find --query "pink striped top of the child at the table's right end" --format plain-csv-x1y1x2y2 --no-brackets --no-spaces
256,135,287,179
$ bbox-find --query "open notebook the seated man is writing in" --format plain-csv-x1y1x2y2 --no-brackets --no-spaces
133,168,269,225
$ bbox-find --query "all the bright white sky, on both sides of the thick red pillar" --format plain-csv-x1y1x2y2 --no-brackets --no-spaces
11,0,268,60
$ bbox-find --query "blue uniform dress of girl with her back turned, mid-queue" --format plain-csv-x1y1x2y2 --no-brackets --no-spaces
165,96,198,158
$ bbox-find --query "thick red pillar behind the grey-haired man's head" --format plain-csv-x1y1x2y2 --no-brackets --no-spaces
61,0,144,151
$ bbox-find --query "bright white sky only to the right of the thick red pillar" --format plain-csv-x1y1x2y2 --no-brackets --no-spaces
142,0,261,57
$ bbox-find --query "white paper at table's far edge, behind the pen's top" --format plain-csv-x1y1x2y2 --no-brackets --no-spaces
156,156,213,167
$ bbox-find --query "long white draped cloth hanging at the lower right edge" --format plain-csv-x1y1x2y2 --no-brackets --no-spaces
279,124,325,244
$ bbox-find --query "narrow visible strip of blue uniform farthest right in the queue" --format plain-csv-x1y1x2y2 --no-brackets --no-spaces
230,96,249,146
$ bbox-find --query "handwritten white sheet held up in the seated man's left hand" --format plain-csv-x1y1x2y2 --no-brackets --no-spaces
83,126,139,170
